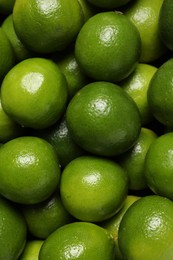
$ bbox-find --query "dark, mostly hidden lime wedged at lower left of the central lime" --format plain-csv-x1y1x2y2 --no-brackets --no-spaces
33,115,86,169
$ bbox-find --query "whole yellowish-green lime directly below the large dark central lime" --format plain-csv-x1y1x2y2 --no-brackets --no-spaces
60,156,128,222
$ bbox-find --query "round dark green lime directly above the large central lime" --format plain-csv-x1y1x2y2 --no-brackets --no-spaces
75,11,141,82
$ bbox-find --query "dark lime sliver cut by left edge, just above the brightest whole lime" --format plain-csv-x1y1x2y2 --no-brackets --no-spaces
0,27,15,83
